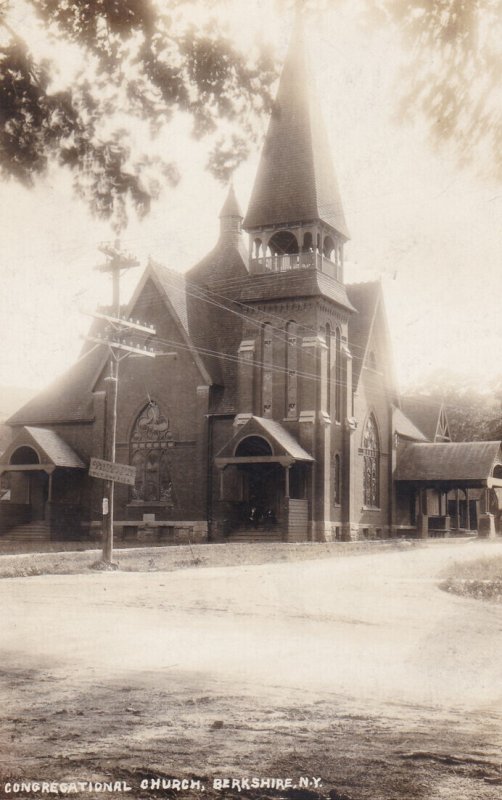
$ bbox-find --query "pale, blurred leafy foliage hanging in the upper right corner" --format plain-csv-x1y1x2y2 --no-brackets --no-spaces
356,0,502,180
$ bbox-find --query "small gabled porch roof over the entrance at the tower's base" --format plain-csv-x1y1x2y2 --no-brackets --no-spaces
215,416,314,466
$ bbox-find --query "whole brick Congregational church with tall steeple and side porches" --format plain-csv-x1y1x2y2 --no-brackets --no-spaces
0,20,502,542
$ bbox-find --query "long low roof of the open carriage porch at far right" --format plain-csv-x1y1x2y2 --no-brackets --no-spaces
397,442,501,483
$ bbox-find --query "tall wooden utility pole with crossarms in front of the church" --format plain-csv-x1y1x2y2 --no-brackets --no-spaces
86,240,156,564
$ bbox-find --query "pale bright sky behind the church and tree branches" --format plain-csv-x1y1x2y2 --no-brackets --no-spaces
0,0,502,396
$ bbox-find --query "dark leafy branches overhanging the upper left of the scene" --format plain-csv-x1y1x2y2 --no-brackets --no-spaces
0,0,277,229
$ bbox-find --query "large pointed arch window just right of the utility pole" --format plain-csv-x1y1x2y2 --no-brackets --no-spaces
130,401,174,508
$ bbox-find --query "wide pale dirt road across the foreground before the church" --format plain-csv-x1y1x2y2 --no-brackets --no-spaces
0,542,502,800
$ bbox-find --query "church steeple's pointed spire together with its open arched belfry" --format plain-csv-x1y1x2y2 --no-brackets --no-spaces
243,12,349,280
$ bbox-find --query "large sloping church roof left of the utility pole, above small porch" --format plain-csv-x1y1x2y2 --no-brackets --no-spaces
7,345,108,425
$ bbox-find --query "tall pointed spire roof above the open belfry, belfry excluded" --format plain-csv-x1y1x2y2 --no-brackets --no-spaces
244,21,349,238
